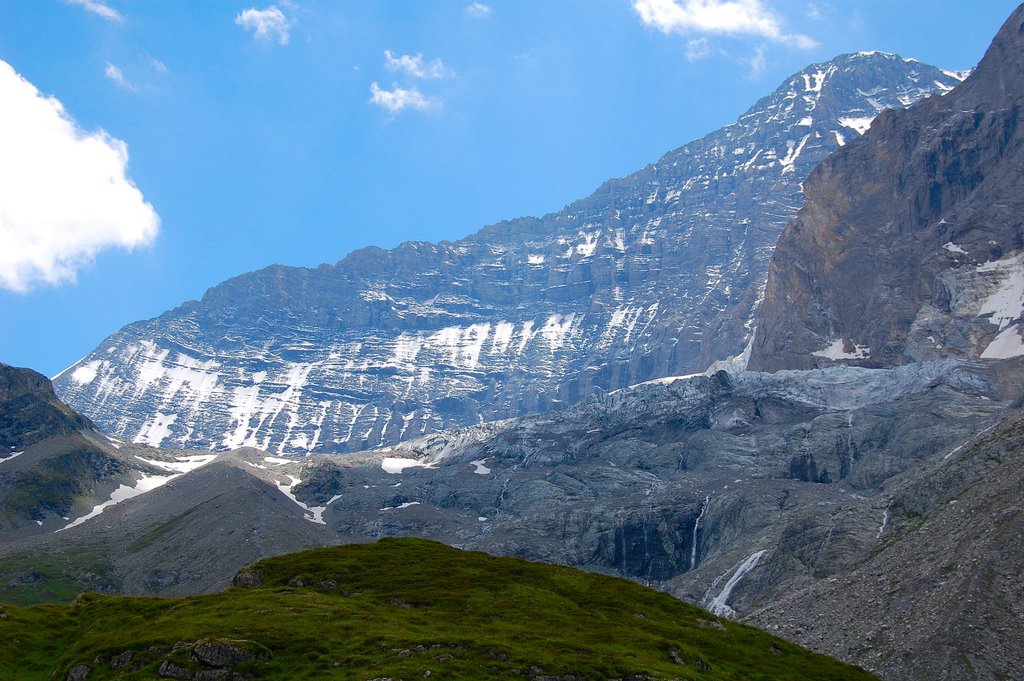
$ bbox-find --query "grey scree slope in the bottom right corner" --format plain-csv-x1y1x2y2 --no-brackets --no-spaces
750,409,1024,681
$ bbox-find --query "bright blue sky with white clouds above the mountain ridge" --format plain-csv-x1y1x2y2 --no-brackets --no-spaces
0,0,1016,375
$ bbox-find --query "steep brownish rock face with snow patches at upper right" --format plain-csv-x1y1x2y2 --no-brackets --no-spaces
750,9,1024,371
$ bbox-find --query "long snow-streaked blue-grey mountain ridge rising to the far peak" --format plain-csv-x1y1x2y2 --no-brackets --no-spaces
54,52,963,454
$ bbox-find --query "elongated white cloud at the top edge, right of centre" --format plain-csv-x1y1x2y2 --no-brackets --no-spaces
633,0,817,49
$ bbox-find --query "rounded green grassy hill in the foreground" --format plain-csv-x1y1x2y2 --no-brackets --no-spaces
0,539,874,681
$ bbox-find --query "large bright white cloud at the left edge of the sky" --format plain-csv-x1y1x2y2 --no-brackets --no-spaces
0,60,160,292
